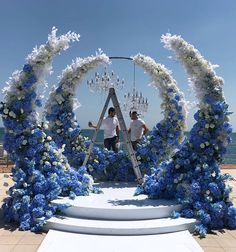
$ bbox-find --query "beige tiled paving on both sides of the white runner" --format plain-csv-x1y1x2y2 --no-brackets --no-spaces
0,169,236,252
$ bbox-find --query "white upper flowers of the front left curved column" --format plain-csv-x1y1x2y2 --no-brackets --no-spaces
3,27,80,122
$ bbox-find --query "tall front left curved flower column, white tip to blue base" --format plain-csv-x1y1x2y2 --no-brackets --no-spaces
0,28,93,231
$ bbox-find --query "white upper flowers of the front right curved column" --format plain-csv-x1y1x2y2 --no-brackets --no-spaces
162,33,230,148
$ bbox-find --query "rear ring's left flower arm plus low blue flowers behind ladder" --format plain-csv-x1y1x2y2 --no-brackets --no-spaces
45,50,139,181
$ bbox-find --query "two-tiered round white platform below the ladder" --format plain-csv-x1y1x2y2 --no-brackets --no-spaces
44,183,197,235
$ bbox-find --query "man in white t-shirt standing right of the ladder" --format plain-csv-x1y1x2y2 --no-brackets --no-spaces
128,111,148,150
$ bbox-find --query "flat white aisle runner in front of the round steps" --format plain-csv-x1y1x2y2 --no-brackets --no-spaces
38,230,203,252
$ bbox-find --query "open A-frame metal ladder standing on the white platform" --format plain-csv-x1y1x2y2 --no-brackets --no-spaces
83,88,143,184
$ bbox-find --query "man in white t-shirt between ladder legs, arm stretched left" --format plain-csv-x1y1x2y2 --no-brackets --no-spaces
88,107,120,152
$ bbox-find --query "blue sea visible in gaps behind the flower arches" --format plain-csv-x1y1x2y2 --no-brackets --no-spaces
0,127,236,164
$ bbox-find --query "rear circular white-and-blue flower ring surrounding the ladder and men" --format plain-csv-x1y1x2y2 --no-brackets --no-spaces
45,51,186,181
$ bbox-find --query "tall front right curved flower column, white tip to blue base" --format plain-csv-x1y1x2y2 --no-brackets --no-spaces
140,34,236,237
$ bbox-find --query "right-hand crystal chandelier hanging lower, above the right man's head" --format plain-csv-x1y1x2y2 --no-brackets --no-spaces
123,63,148,114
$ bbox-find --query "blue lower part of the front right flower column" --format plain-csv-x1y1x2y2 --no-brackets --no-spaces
141,97,236,236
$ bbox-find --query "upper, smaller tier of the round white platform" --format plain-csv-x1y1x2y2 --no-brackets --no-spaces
53,183,181,220
